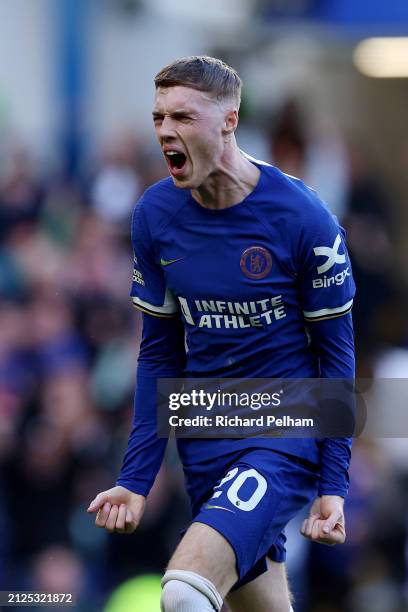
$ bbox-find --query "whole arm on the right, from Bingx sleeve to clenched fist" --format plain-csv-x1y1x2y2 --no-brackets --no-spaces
294,191,355,544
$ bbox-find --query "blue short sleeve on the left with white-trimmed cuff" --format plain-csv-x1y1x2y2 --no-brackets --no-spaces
130,197,179,317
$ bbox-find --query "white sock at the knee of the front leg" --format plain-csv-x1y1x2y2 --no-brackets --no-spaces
160,570,222,612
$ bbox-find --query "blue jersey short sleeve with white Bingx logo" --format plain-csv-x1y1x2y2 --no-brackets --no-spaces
297,196,355,323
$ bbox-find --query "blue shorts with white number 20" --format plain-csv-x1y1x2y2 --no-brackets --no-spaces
185,449,319,589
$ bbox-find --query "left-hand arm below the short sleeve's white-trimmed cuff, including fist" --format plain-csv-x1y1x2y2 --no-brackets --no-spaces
88,314,185,533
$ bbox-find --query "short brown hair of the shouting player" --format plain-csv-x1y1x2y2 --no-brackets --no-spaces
154,55,242,108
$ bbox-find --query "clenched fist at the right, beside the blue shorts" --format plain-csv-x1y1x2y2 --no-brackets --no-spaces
300,495,346,546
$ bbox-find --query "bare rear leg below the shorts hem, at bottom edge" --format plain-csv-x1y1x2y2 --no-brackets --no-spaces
227,559,291,612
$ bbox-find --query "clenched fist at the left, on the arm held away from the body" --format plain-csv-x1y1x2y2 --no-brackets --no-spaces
87,486,146,533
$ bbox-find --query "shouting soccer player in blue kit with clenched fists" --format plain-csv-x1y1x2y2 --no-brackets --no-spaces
88,56,354,612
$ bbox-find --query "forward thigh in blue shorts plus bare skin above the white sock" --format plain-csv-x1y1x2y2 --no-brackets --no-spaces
180,449,318,595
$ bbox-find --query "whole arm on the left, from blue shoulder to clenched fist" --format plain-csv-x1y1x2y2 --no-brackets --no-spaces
88,197,185,533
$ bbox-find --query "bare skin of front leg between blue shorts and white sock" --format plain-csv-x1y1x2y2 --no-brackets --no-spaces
167,523,238,598
